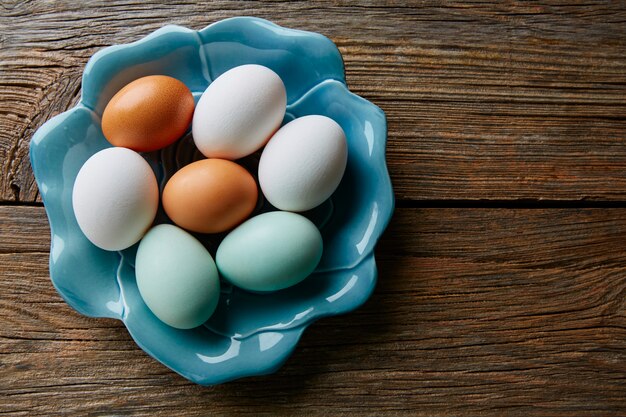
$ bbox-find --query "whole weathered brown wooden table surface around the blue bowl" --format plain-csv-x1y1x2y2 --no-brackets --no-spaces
0,0,626,416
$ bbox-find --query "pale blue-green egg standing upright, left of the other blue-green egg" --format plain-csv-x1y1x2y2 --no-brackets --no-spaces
135,224,220,329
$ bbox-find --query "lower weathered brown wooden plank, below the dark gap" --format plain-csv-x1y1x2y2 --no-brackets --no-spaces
0,207,626,416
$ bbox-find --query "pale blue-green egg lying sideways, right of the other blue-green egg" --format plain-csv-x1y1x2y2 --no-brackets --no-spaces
215,211,323,292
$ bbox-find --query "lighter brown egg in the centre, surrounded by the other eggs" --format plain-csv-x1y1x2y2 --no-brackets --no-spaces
163,159,258,233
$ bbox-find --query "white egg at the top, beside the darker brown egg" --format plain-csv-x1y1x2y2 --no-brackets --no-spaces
192,65,287,160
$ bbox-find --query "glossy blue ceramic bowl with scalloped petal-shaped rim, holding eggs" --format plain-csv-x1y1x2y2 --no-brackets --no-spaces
30,17,394,385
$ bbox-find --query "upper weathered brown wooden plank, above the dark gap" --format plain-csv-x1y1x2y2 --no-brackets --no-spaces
0,0,626,201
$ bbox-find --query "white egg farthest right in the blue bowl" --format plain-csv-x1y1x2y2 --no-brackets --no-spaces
259,115,348,211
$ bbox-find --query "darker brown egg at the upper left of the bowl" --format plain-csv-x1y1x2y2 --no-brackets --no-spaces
102,75,194,152
